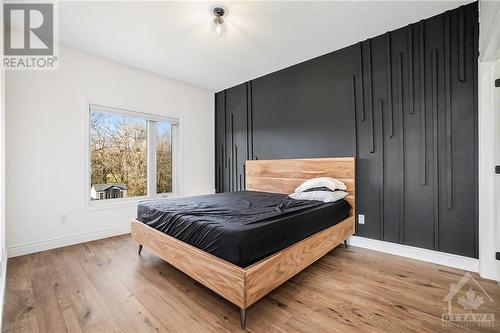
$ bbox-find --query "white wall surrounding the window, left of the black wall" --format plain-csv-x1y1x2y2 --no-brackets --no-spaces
6,47,214,256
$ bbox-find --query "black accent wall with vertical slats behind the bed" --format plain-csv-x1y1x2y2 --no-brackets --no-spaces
215,3,479,258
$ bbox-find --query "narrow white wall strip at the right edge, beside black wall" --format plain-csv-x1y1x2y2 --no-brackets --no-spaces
478,0,500,281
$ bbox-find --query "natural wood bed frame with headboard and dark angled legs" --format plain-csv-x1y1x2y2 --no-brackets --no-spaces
132,157,355,328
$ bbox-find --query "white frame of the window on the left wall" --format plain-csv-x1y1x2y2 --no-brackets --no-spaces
84,103,181,208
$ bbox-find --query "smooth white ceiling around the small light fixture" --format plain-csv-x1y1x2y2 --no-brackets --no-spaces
59,1,470,91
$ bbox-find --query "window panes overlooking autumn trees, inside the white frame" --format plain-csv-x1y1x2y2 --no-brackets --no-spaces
89,104,178,201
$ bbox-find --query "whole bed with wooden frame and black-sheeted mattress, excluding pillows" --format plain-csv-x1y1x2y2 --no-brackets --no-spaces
132,157,355,328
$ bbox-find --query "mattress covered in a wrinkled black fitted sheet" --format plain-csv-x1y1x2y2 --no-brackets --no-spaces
137,191,351,267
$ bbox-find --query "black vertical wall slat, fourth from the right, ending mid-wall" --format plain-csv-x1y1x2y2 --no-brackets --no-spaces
419,22,427,185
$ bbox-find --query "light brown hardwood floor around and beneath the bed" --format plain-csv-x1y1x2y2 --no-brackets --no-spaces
3,236,500,332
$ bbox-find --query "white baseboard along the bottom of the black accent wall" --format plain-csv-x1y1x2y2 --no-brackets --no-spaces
349,236,479,273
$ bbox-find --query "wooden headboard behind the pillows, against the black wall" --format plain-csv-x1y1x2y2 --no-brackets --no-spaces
246,157,356,215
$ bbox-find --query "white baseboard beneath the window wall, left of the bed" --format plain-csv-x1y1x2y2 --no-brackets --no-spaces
7,224,130,258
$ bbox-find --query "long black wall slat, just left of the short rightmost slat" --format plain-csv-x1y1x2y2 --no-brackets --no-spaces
444,13,452,209
